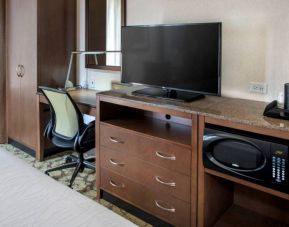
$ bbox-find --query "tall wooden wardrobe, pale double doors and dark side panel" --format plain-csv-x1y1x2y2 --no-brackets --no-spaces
6,0,76,150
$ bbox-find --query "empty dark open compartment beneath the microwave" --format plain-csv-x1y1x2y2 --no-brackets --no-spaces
204,173,289,227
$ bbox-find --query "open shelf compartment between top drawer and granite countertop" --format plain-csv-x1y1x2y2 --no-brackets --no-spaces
100,102,192,148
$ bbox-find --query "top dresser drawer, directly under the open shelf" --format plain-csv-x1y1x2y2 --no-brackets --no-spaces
100,123,191,175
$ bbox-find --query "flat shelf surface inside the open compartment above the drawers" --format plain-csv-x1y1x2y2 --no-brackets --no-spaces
101,116,192,148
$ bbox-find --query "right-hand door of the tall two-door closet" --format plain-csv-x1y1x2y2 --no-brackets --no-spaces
14,0,37,150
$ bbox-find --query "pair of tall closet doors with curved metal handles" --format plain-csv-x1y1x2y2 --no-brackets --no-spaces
7,0,37,149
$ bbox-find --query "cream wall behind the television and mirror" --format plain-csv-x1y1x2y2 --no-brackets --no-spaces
79,0,289,101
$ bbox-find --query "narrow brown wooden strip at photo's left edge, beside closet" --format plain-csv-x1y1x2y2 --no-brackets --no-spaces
0,0,6,143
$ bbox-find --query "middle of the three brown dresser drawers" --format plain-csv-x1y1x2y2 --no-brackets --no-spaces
100,147,190,202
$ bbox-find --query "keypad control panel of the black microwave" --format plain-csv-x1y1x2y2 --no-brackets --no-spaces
271,145,288,184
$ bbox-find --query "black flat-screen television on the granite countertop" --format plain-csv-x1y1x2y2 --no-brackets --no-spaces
121,23,222,101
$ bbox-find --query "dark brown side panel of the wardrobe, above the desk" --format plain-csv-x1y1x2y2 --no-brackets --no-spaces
37,0,76,87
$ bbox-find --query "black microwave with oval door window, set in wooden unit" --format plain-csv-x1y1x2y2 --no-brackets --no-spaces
203,128,289,193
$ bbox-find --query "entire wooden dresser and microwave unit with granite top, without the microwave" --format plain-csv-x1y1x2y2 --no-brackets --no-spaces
96,87,289,227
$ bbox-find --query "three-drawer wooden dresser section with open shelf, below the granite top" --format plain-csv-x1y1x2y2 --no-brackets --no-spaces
96,98,197,226
